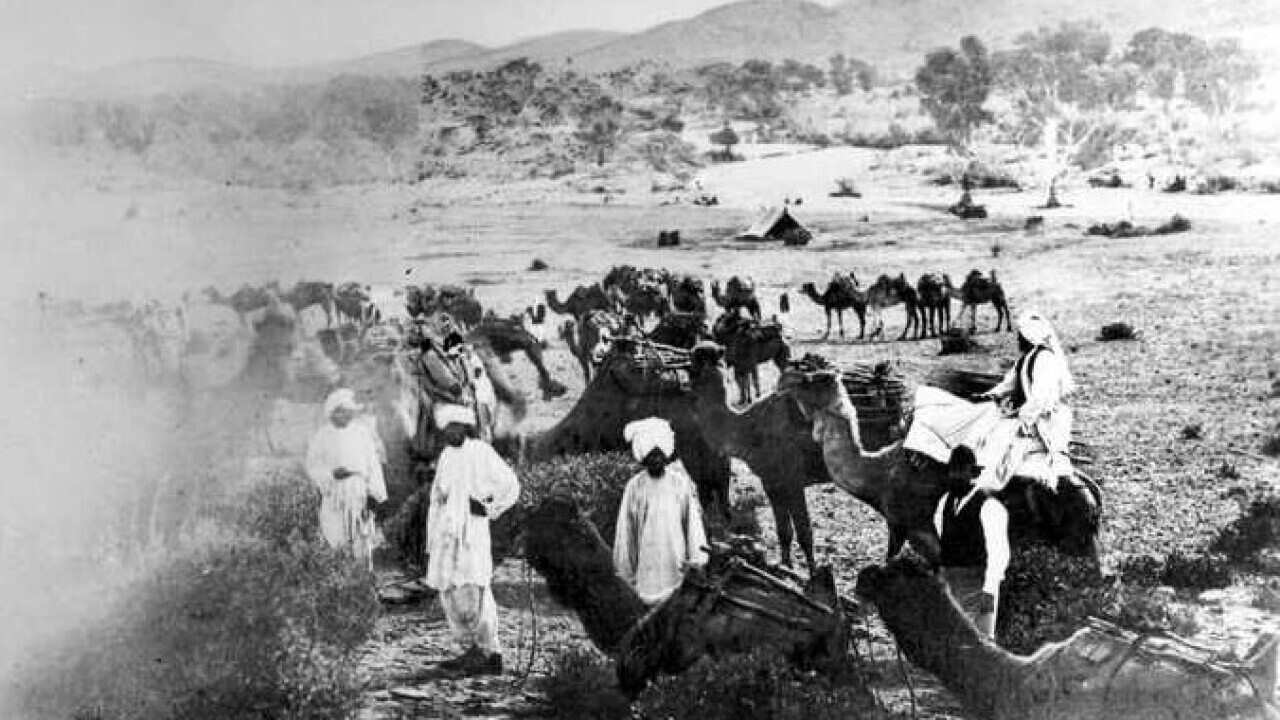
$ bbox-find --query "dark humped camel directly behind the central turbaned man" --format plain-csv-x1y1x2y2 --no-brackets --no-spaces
531,338,730,518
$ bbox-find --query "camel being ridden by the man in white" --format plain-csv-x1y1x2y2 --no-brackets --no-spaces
778,370,1102,562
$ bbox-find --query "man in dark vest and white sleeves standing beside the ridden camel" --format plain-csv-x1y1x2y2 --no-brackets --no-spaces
933,446,1010,638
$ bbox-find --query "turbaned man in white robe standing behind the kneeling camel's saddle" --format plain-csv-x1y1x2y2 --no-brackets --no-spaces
613,418,707,605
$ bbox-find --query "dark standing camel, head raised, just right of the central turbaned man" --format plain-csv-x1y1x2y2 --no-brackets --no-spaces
690,345,832,570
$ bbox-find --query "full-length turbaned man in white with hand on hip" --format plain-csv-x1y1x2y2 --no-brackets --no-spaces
425,405,520,674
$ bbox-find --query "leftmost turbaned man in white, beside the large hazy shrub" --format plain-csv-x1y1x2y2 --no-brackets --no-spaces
306,388,387,570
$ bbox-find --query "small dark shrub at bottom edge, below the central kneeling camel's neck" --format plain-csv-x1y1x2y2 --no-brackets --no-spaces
541,647,631,720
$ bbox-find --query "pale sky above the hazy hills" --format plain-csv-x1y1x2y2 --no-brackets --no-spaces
0,0,836,69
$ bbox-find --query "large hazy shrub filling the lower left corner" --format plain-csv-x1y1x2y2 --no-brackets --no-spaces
12,478,378,719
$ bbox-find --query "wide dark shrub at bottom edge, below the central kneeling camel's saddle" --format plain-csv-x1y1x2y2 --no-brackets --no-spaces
635,651,890,720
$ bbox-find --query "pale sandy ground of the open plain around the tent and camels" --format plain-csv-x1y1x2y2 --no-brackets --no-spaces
0,141,1280,717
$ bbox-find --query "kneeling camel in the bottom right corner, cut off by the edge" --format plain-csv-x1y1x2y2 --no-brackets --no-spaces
856,561,1280,720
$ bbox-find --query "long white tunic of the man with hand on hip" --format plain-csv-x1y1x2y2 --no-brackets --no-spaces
426,438,520,591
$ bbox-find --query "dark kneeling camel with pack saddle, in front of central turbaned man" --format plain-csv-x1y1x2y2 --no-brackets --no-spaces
521,496,849,692
